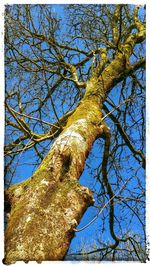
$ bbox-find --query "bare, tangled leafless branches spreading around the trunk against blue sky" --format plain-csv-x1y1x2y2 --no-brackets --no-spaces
5,4,146,262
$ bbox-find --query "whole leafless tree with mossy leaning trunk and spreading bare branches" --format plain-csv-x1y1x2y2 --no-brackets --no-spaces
4,5,146,264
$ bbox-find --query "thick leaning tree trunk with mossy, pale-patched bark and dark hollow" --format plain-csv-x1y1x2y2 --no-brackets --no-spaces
5,53,134,264
